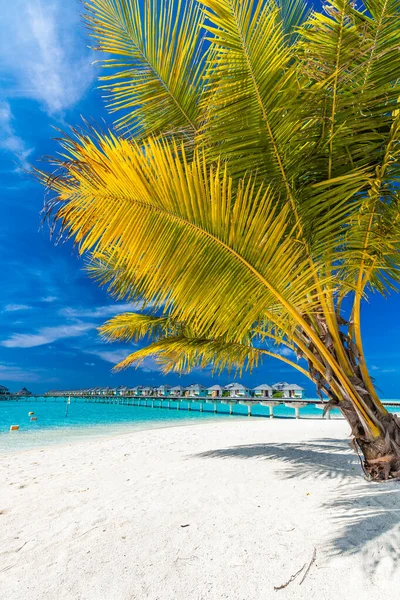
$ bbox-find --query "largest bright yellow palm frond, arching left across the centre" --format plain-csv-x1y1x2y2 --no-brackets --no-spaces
41,131,328,346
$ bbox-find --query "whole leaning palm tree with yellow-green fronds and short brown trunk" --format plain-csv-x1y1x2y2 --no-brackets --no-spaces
41,0,400,480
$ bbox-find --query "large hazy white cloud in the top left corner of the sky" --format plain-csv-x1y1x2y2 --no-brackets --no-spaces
0,0,94,114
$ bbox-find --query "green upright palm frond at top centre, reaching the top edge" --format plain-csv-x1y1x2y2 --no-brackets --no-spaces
201,0,299,184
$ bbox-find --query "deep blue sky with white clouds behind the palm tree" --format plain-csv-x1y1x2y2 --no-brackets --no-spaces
0,0,400,398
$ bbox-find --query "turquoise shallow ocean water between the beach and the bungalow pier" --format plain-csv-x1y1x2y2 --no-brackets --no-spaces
0,398,400,452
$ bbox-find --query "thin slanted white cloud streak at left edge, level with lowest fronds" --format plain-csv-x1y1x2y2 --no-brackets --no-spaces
0,323,96,348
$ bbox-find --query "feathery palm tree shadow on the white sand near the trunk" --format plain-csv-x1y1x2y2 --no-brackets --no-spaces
196,438,400,576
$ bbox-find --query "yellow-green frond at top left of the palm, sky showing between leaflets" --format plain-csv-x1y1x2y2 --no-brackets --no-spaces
84,0,204,137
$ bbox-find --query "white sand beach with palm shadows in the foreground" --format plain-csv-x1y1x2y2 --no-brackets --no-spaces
0,419,400,600
